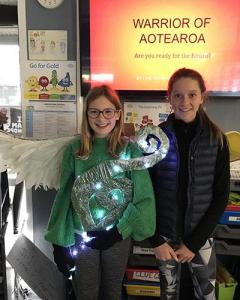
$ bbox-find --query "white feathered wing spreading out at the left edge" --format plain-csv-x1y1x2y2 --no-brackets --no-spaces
0,131,76,189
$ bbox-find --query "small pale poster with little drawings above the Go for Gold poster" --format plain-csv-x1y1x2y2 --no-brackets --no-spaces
28,30,67,60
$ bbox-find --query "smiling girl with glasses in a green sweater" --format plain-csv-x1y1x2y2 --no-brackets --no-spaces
45,85,155,300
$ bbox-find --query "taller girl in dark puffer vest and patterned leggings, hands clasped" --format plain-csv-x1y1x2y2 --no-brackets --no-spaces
150,68,230,300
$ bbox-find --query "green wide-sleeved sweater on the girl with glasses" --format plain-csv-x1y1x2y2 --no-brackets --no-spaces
45,138,156,246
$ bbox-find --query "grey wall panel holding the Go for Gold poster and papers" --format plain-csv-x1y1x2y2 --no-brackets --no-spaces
19,0,78,139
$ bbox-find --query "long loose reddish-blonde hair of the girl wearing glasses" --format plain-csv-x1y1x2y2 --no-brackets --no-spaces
78,85,124,159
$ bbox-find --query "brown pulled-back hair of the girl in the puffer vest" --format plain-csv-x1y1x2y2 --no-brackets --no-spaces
167,68,223,146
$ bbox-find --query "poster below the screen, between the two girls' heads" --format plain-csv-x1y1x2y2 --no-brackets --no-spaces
124,102,170,131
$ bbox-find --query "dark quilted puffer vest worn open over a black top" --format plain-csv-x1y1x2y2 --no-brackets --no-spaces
149,115,218,240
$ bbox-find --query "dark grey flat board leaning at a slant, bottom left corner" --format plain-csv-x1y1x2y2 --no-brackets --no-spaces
7,235,66,300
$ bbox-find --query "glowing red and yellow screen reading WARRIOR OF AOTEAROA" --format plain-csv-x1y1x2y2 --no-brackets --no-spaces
89,0,240,92
